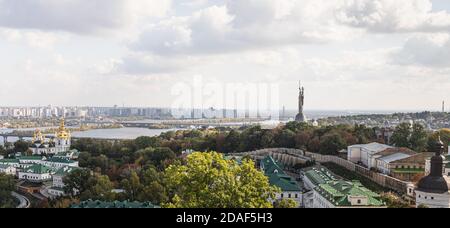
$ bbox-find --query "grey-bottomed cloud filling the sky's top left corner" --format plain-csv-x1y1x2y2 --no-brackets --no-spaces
0,0,171,34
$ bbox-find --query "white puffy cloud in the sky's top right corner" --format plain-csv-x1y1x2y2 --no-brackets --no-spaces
336,0,450,33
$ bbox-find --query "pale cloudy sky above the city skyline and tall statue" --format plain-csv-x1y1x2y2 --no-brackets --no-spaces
0,0,450,110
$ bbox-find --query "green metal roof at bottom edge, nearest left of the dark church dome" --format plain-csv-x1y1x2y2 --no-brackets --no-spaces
315,180,386,207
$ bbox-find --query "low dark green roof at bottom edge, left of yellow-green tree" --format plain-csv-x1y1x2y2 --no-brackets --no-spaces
71,200,159,208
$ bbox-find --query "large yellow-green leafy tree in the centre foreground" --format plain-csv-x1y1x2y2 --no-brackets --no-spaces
163,152,277,208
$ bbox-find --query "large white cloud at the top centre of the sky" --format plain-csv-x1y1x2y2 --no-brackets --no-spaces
131,0,357,55
